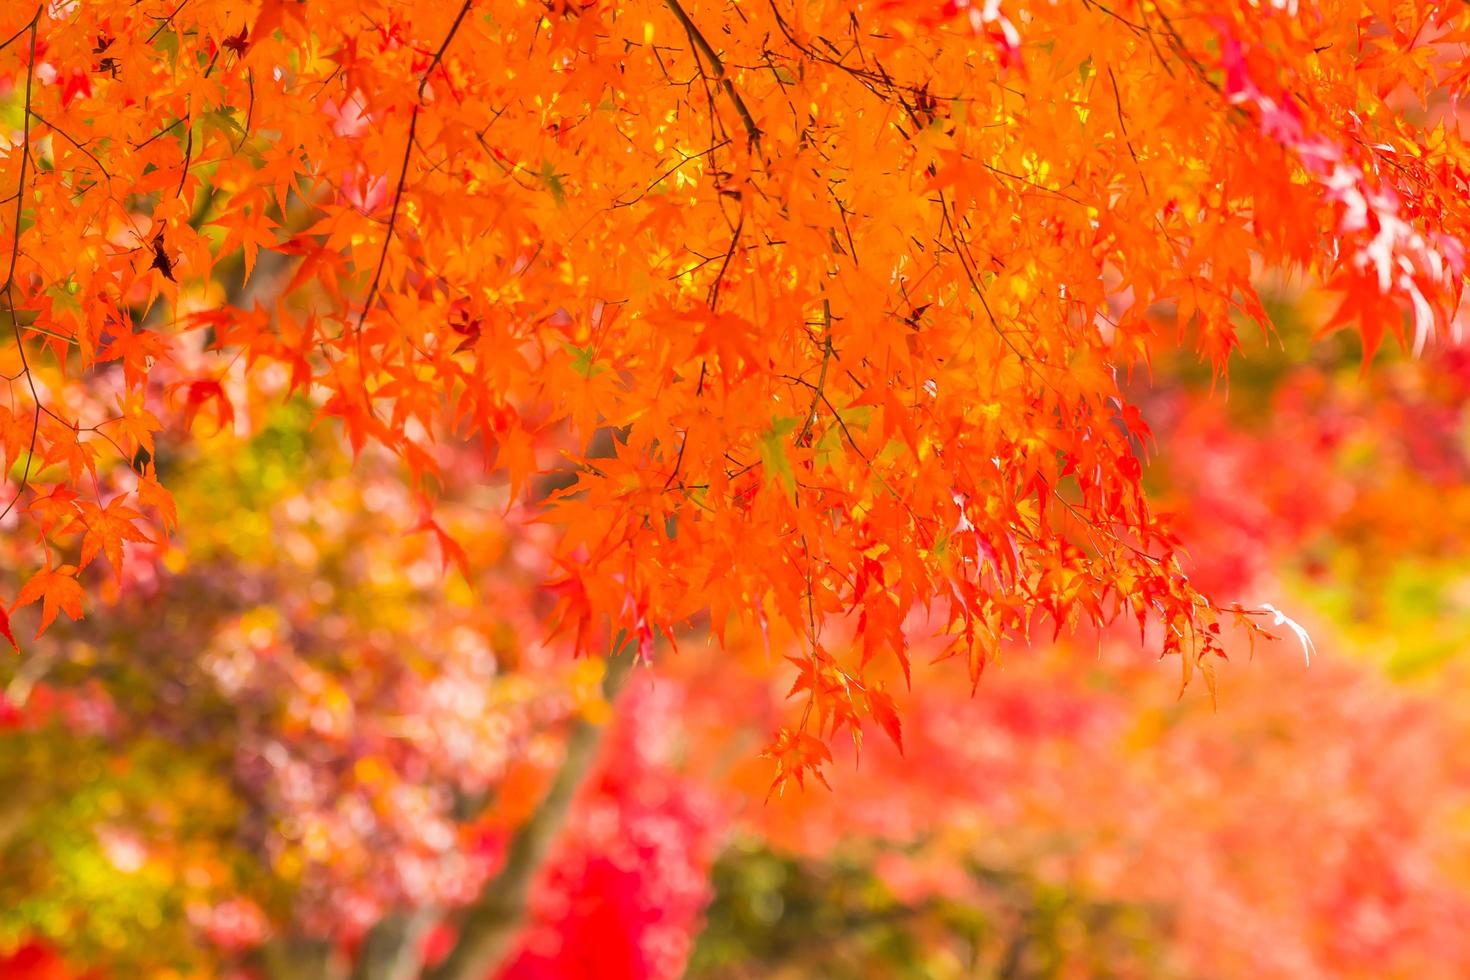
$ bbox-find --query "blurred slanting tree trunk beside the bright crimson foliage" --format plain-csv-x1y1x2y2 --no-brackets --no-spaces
423,642,638,980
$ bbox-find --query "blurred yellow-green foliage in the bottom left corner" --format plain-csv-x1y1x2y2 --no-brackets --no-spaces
0,723,250,977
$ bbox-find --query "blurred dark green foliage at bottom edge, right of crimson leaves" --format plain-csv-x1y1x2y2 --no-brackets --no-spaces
688,840,1169,980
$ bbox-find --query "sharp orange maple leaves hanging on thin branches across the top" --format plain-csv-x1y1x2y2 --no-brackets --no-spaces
0,0,1470,780
